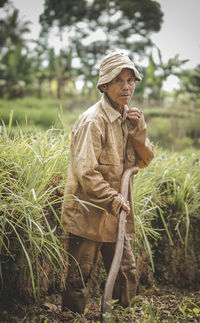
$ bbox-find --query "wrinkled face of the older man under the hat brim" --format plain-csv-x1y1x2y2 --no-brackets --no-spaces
101,68,135,111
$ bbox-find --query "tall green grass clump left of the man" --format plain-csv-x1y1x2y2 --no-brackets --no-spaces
0,121,69,298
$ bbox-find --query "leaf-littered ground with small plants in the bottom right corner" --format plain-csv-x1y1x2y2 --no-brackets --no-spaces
101,291,200,323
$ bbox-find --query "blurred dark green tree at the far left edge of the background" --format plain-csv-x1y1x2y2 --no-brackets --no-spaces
0,1,32,98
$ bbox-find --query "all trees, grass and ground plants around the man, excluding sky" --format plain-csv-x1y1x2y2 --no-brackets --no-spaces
0,0,200,323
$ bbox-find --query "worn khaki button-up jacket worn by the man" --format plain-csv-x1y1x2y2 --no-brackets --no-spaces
62,95,154,242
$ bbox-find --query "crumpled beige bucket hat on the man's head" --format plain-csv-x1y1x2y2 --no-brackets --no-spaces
97,52,142,89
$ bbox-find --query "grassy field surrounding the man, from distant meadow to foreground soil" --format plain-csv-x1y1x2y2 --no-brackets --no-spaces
0,98,200,322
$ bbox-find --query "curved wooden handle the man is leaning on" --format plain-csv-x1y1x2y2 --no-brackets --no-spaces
101,166,139,319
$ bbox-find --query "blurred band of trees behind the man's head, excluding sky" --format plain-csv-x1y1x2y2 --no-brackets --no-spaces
0,0,199,108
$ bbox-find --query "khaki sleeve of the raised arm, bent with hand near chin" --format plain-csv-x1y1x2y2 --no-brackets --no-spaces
129,114,154,168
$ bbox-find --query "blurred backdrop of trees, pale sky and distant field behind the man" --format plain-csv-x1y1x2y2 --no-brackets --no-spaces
0,0,200,150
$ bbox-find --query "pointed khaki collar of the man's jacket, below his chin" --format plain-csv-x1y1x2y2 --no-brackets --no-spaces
101,94,128,123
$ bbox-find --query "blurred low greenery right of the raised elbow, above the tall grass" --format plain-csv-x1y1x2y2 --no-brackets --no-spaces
144,104,200,151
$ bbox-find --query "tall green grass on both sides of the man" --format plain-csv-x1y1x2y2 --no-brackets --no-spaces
0,105,200,306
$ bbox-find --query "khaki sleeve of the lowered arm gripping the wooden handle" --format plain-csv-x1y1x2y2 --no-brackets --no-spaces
72,122,124,216
